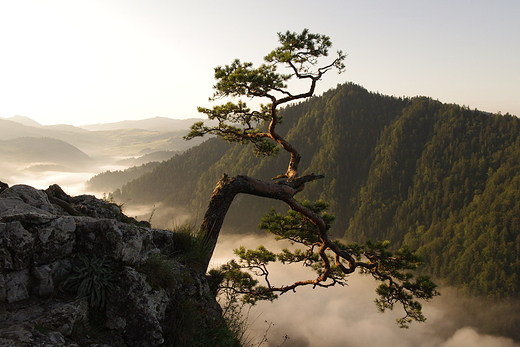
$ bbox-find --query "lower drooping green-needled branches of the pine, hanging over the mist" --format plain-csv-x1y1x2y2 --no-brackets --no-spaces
212,201,439,328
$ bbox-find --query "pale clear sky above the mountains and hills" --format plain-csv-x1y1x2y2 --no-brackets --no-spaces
0,0,520,125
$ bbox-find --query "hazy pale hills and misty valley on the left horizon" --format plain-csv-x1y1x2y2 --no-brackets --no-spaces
0,116,211,192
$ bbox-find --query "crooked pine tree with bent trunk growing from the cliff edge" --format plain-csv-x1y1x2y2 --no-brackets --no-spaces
185,29,438,327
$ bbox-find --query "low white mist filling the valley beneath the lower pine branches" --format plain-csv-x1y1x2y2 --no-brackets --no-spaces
213,235,520,347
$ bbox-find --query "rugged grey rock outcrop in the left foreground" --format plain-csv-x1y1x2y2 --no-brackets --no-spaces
0,184,228,347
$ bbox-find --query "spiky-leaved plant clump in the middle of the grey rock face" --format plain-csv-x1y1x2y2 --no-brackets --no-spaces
62,254,114,309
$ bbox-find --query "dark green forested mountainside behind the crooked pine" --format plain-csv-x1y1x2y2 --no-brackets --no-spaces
113,84,520,298
